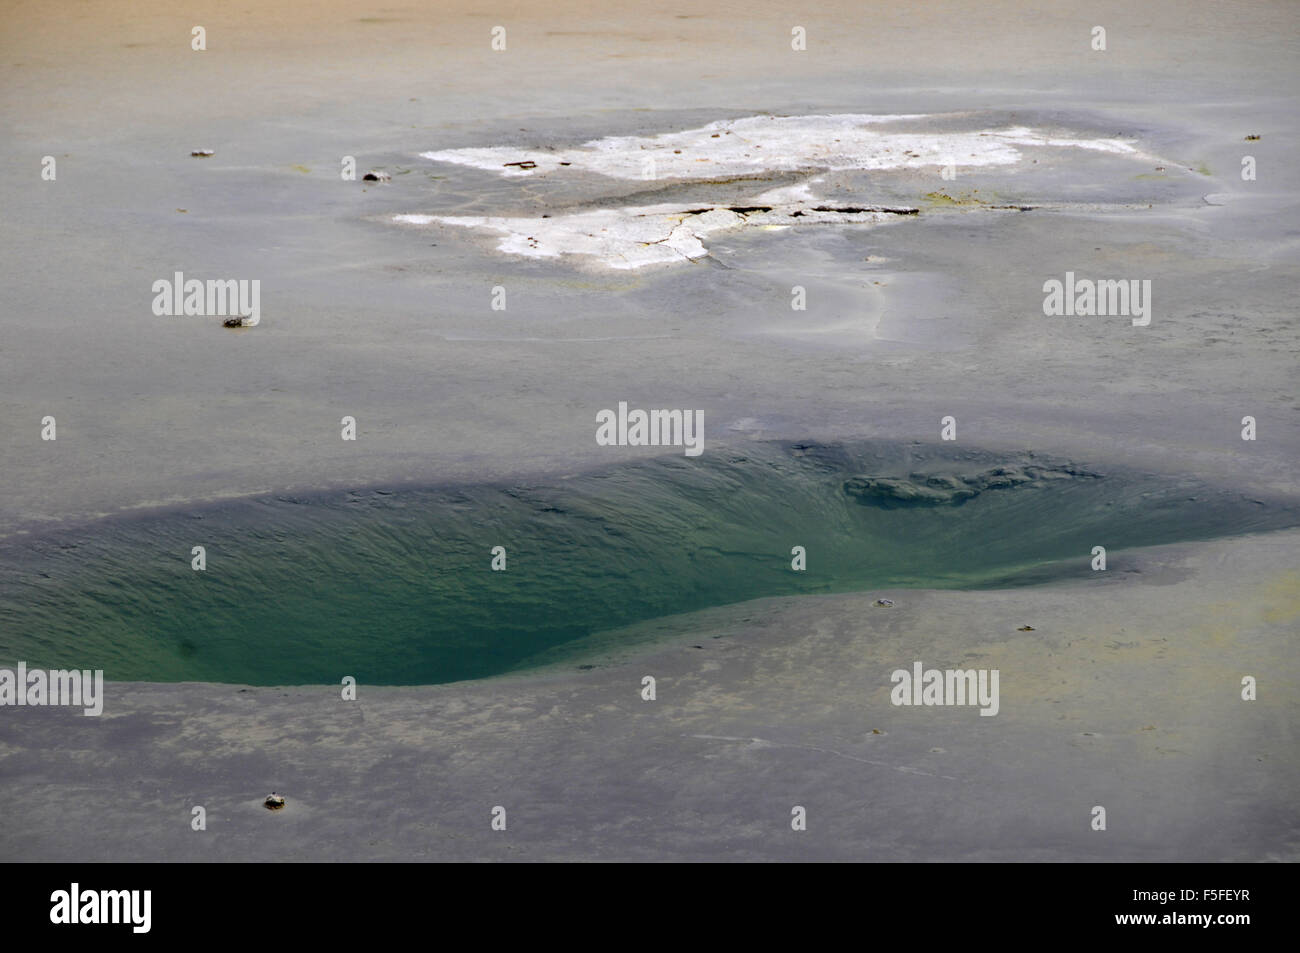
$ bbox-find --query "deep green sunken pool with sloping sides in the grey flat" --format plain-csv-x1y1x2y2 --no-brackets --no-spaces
0,445,1300,685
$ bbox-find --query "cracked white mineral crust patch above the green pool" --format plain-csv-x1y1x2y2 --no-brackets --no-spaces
394,114,1170,269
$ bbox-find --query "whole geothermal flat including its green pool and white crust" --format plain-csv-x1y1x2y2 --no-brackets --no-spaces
0,3,1300,861
